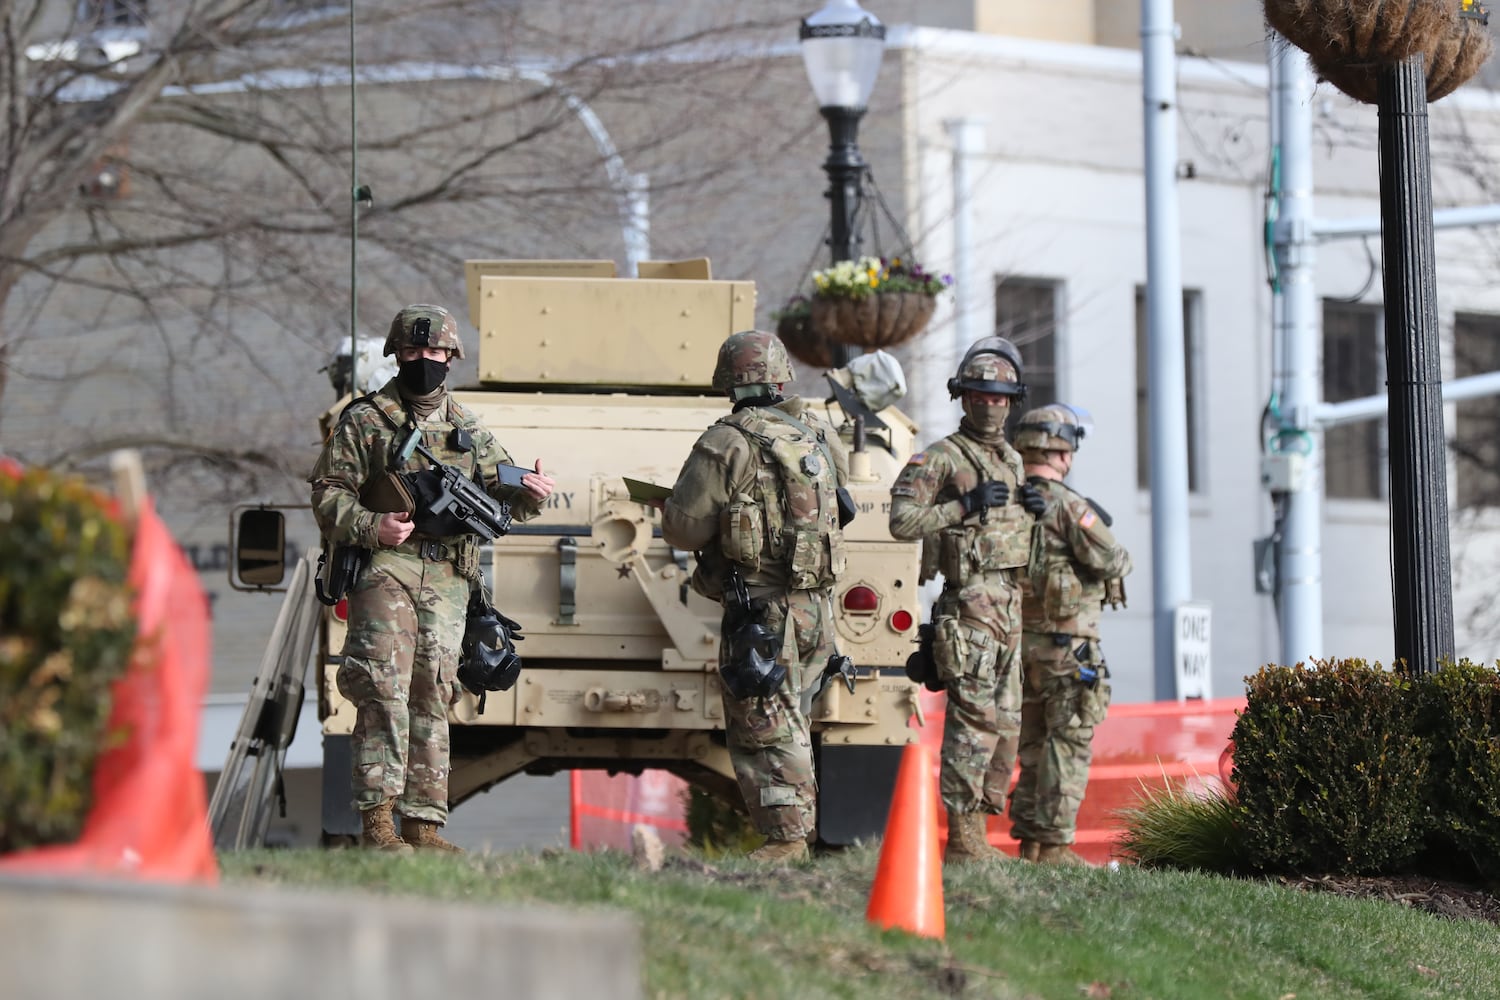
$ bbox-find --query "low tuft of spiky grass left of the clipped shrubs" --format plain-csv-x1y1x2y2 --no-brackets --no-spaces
1116,781,1250,874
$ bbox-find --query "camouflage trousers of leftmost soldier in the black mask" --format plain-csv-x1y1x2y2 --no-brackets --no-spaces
338,550,470,823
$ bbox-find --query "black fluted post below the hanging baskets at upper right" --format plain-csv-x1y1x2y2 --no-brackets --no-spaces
1377,55,1454,673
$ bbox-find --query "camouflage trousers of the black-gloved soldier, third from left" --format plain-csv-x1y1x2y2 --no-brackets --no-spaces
933,582,1022,816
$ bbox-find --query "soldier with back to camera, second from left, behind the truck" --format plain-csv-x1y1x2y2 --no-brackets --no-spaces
662,330,849,864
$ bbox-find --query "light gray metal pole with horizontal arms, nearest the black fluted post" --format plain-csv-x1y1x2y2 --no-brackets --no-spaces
1269,42,1323,666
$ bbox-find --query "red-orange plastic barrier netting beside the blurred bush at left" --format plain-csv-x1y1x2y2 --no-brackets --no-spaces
0,485,219,882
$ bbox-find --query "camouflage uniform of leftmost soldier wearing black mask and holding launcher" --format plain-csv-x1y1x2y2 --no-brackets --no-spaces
309,308,537,823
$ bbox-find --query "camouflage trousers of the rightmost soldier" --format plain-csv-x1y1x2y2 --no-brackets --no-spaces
1011,633,1110,844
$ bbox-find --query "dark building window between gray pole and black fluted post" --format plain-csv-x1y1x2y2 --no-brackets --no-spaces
1323,300,1386,499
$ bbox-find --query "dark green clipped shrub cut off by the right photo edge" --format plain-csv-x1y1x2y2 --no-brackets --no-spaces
1419,660,1500,879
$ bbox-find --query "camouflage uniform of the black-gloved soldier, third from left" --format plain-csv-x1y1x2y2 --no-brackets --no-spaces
891,427,1035,816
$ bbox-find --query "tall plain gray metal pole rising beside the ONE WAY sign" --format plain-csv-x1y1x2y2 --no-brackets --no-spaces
1140,0,1193,702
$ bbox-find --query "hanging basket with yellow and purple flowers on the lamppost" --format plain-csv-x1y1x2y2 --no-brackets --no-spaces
812,256,953,349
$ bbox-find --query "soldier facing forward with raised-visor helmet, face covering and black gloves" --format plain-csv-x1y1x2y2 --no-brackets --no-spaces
891,337,1044,862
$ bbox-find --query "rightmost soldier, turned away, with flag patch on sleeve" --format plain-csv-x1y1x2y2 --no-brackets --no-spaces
1011,403,1131,864
